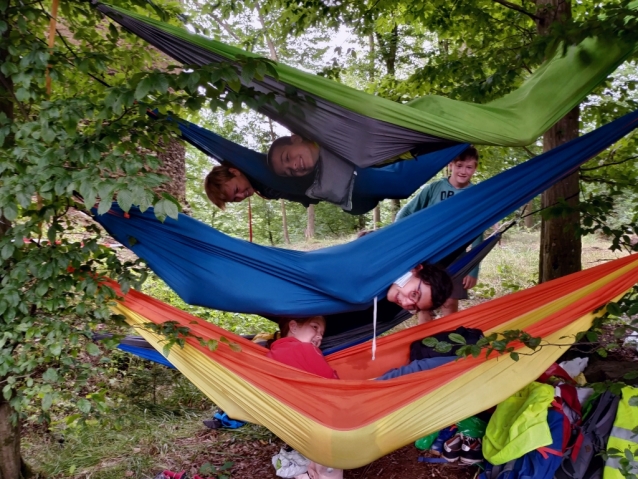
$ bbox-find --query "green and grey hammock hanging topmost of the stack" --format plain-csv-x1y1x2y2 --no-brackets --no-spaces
97,4,635,154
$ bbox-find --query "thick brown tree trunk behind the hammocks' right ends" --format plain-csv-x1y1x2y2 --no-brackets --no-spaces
536,0,582,283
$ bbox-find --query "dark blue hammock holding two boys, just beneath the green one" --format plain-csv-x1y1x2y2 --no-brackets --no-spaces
175,115,468,215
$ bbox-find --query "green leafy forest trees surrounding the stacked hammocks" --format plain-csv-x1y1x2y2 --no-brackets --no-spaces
0,0,638,479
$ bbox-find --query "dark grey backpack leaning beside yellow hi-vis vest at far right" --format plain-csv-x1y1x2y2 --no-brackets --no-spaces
554,391,620,479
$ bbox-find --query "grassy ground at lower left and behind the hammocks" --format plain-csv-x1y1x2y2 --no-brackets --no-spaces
22,230,623,479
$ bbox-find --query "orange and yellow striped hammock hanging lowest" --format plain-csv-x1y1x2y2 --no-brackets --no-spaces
112,255,638,469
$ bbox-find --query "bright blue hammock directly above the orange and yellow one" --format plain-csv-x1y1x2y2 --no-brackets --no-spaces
96,111,638,316
